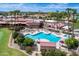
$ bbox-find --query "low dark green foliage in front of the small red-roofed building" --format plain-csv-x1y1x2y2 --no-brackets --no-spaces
41,49,66,56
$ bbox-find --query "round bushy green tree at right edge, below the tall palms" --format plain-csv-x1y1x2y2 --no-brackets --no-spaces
65,38,79,49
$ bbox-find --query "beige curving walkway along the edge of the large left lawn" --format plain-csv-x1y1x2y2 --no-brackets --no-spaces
8,33,41,56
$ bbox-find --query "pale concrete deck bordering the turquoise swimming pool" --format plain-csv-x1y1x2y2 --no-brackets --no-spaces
23,29,69,42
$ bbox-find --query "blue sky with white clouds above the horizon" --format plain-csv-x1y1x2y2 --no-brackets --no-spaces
0,3,79,12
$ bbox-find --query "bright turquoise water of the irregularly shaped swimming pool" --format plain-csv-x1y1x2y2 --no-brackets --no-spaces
25,32,61,43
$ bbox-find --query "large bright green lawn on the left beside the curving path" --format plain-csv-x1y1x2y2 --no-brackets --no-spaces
0,28,25,56
